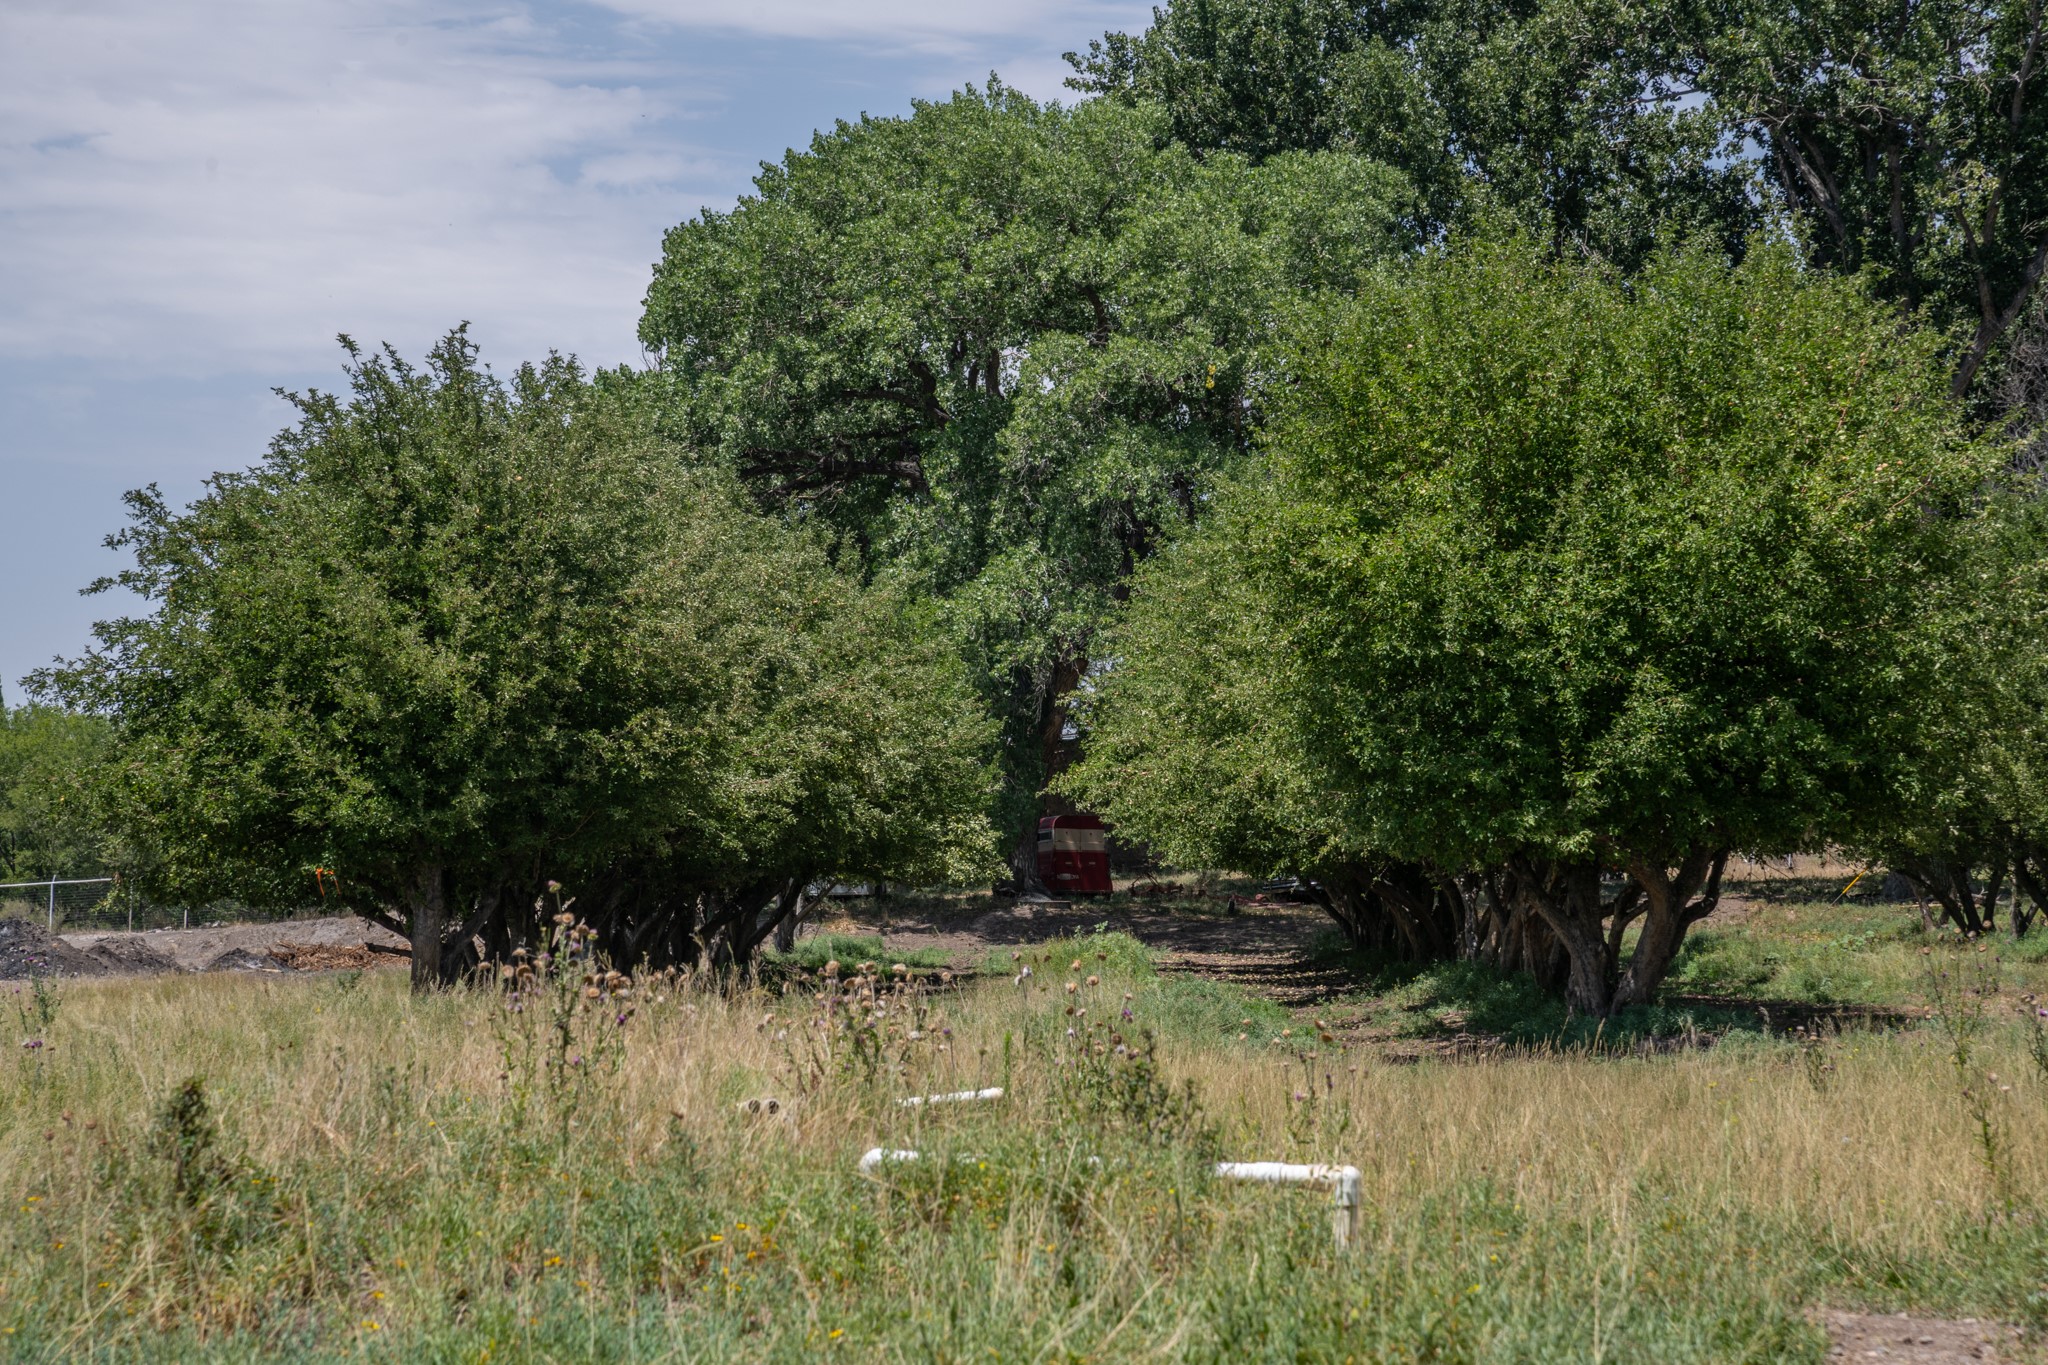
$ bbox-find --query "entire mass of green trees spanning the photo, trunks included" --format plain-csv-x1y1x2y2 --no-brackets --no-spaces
39,0,2048,1011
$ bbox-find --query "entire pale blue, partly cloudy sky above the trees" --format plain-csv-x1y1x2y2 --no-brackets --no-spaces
0,0,1151,702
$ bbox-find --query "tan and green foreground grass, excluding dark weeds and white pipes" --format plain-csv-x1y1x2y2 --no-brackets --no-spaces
0,950,2048,1361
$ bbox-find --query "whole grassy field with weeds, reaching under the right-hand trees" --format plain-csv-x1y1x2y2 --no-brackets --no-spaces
0,907,2048,1361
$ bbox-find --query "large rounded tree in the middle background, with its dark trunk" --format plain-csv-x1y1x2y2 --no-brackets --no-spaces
641,84,1407,872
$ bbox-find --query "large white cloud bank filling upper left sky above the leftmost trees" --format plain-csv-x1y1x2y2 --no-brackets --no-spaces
0,0,735,370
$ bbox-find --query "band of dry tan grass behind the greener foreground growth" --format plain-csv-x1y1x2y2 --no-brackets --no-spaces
0,957,2048,1242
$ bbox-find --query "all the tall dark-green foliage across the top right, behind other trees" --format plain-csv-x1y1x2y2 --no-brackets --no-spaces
1071,0,2048,395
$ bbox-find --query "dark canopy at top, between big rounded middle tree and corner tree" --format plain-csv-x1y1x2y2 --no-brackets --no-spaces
1067,0,1757,264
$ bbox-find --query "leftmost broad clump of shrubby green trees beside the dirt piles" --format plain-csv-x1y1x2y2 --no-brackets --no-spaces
29,334,989,980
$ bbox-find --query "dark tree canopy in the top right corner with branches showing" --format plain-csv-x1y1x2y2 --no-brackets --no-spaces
1683,0,2048,397
